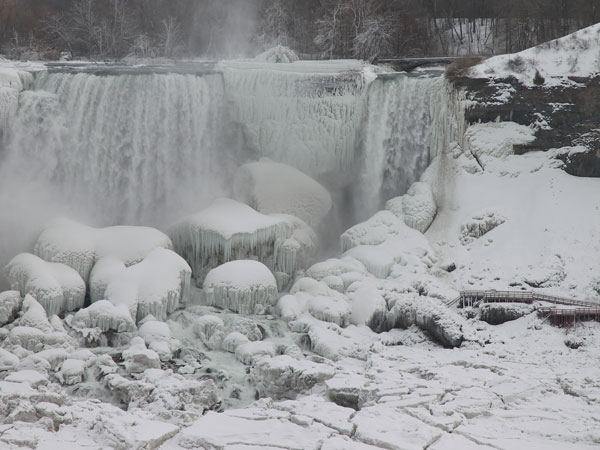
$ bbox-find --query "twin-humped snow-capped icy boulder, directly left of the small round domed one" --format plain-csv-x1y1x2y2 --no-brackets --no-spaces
90,248,192,322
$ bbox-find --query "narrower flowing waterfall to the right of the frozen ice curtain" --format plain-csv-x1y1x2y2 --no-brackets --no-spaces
354,75,464,220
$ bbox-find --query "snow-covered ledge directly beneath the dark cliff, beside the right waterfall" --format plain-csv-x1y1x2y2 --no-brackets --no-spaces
465,122,535,170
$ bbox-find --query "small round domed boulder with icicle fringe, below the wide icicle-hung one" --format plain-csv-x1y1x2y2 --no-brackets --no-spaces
204,260,278,314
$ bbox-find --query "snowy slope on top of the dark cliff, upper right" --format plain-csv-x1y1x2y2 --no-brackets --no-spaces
469,24,600,86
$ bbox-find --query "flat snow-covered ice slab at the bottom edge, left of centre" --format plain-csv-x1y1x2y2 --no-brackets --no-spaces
177,412,327,450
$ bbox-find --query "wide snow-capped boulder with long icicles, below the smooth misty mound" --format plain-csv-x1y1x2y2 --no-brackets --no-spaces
169,198,315,286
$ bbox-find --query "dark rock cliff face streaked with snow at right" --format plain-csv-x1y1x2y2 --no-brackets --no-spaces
454,77,600,177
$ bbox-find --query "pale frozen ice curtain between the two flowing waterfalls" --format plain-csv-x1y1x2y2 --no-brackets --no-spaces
219,61,367,177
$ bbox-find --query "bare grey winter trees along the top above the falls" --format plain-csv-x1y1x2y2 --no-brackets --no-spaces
0,0,600,60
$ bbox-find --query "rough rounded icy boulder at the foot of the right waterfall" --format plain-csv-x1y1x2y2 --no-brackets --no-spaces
385,182,437,233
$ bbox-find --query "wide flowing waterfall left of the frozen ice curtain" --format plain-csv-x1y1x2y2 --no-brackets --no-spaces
3,72,227,225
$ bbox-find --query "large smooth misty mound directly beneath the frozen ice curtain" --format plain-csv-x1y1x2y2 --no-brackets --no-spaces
233,158,332,227
